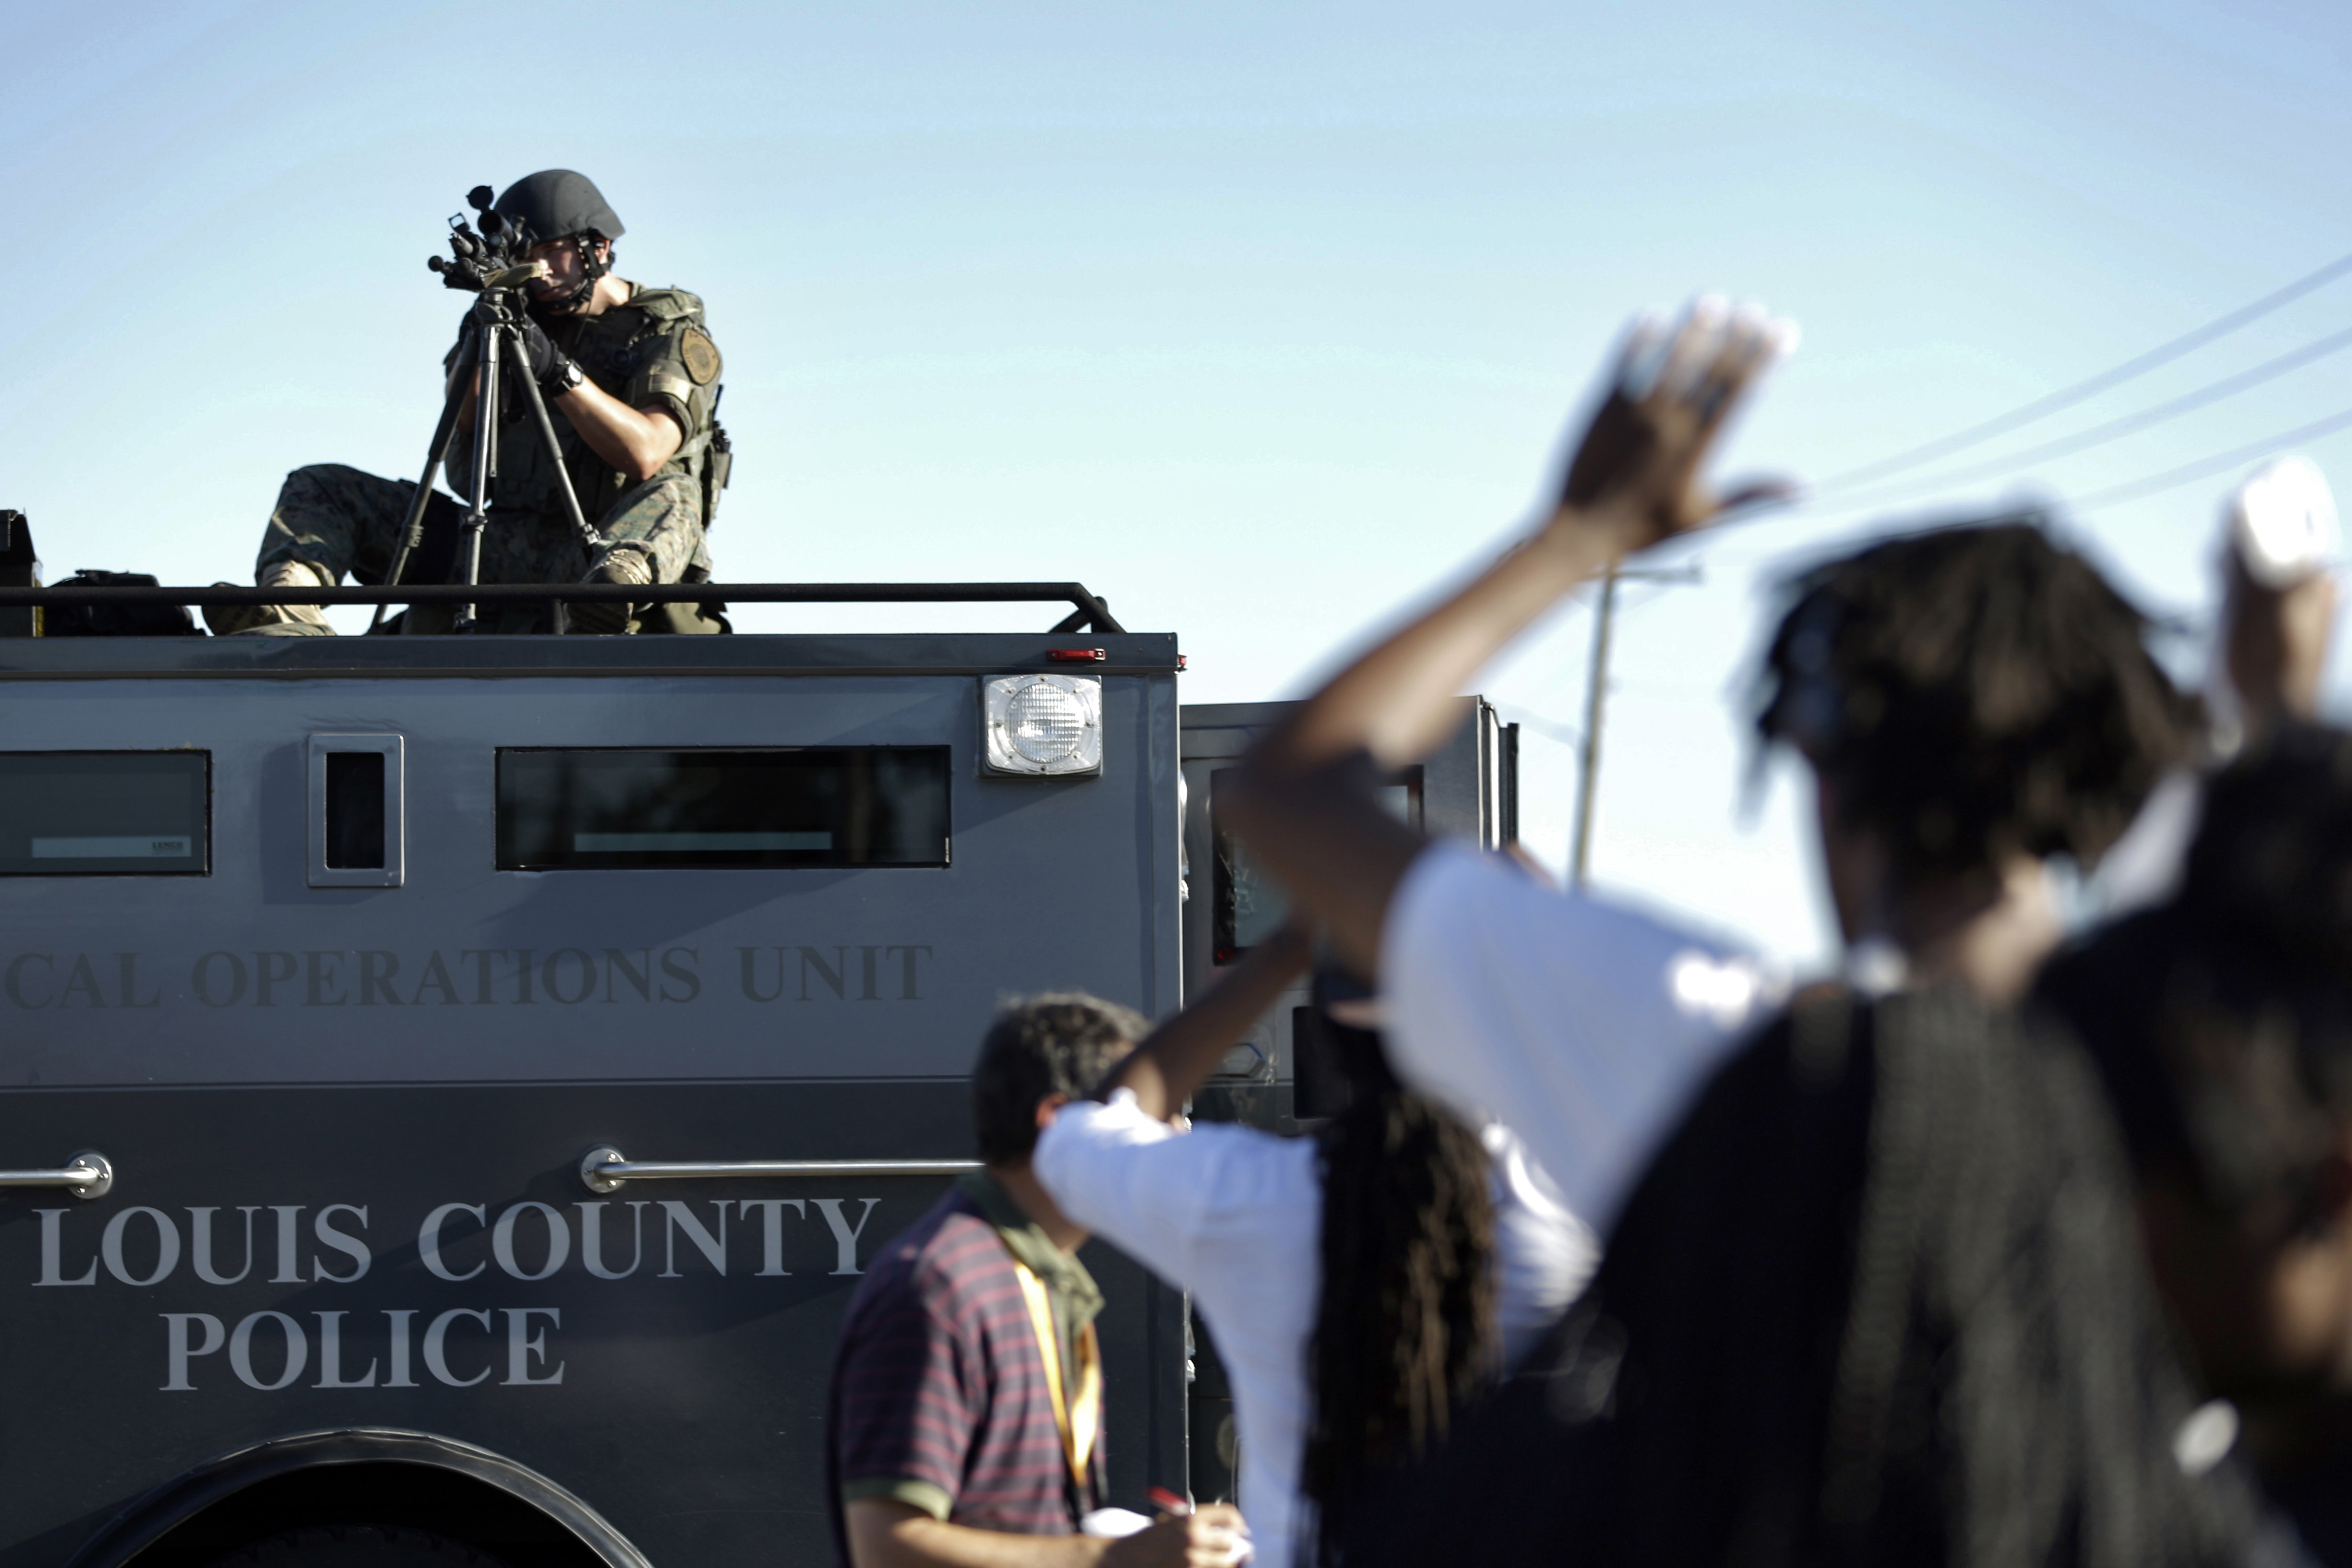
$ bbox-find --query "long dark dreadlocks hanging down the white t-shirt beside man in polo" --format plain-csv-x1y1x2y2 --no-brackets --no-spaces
1298,1023,1496,1563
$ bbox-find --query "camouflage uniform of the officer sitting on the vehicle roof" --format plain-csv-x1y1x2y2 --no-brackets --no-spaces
256,284,720,632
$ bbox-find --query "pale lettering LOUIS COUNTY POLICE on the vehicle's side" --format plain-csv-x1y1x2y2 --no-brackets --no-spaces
33,1199,880,1394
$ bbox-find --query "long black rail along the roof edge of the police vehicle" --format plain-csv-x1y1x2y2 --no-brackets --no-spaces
0,583,1127,635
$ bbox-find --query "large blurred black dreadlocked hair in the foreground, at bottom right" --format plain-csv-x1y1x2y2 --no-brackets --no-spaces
1348,987,2260,1568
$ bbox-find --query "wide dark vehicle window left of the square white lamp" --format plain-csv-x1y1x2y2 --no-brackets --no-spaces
498,745,948,872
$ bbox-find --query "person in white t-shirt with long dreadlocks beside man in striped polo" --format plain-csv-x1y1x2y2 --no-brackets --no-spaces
1035,926,1592,1568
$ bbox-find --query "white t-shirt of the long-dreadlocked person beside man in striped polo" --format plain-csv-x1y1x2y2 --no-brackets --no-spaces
1030,1088,1595,1568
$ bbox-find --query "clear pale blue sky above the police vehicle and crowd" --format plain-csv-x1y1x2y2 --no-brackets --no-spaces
0,0,2352,959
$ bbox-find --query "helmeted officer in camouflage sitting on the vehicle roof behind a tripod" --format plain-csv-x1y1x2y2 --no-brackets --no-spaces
223,169,724,635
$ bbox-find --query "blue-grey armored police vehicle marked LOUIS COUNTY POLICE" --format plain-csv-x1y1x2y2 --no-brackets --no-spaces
0,522,1510,1568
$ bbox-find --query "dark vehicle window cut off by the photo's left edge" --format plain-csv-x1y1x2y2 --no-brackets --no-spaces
0,752,212,877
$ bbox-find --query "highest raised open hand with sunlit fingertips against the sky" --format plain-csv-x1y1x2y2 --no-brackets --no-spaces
1548,296,1797,553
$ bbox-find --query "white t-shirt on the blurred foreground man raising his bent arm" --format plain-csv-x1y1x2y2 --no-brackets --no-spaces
1381,842,1787,1234
